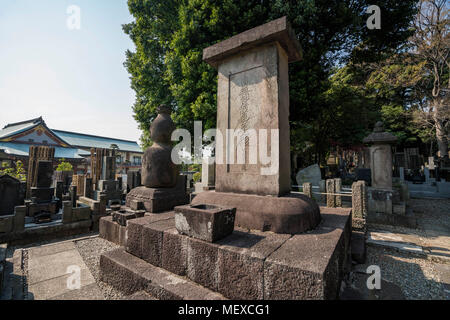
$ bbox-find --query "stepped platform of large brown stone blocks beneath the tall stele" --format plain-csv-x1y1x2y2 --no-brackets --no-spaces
100,208,351,300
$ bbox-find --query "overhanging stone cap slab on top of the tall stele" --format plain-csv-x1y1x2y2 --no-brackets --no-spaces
203,17,302,67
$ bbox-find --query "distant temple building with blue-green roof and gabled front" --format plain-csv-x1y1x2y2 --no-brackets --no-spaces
0,117,143,174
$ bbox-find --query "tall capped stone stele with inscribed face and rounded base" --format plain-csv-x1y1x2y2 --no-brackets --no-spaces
193,17,320,233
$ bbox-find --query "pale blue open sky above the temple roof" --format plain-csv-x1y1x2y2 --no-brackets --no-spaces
0,0,140,141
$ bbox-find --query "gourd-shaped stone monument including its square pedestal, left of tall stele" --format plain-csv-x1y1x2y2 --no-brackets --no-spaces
126,105,188,213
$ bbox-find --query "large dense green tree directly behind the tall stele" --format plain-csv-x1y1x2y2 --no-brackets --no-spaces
123,0,416,161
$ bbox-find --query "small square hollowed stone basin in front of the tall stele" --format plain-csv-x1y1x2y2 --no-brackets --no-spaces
175,204,236,242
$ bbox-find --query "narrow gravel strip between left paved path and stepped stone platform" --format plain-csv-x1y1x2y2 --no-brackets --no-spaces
75,237,123,300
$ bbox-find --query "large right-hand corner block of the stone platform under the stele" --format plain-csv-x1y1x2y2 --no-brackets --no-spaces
264,209,351,300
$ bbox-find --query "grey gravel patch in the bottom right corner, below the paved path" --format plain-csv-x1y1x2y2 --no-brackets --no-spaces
357,242,447,300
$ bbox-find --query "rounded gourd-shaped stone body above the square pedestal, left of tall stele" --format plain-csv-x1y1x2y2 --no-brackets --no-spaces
142,105,178,188
